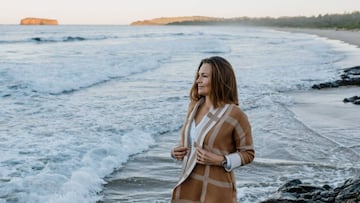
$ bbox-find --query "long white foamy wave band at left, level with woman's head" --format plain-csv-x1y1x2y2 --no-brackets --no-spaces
0,54,166,97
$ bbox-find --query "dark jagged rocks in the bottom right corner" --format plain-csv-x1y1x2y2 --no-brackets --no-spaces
261,177,360,203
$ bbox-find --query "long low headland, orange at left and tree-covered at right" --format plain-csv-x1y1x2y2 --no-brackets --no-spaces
132,11,360,29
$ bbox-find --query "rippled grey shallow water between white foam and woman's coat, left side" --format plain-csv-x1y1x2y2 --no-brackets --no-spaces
98,131,181,203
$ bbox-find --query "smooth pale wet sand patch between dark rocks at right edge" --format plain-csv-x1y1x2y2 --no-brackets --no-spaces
288,87,360,154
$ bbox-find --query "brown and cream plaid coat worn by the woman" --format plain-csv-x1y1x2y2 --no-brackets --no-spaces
171,101,255,203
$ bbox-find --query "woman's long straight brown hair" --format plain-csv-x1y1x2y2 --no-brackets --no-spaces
190,56,239,108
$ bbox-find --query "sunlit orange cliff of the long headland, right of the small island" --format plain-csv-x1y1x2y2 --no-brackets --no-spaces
130,16,223,25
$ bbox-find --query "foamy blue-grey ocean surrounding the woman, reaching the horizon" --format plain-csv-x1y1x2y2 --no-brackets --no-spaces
0,25,360,203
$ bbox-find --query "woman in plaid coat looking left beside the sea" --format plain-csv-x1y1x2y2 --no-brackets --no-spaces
171,56,255,203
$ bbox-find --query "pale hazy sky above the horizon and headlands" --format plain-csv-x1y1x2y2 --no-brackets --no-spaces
0,0,360,25
